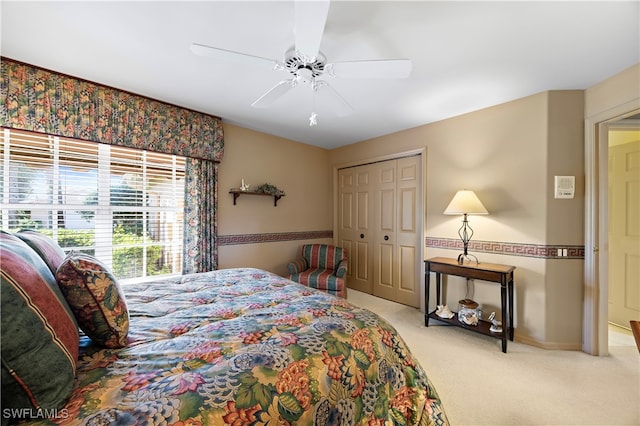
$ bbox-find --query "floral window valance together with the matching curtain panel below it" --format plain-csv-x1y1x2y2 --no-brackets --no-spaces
0,57,224,273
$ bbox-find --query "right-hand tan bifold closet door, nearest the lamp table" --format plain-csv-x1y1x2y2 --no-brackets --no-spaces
373,156,423,307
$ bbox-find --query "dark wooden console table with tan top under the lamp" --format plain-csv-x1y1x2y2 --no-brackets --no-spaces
424,257,516,353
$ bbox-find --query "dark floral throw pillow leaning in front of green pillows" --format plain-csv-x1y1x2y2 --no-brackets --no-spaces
56,252,129,348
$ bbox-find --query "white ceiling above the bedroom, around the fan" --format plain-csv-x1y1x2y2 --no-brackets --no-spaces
0,0,640,148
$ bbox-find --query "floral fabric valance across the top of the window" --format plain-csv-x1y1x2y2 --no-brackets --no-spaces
0,58,224,161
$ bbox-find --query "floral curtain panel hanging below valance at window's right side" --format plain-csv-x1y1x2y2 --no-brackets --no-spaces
182,159,218,274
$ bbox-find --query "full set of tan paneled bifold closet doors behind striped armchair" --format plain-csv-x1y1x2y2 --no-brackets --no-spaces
338,156,423,307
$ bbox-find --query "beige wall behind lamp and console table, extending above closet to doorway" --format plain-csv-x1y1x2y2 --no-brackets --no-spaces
330,91,584,349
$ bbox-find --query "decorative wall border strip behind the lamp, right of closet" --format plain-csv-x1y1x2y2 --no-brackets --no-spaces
425,237,584,259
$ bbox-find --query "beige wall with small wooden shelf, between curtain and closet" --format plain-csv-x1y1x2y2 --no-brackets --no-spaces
218,123,333,275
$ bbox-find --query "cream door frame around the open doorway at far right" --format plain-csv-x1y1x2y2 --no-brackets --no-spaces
582,100,639,356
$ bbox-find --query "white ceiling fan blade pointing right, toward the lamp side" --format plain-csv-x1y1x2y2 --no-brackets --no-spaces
325,59,413,78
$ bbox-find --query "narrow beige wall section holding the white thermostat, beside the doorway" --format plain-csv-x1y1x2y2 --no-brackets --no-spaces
544,91,585,349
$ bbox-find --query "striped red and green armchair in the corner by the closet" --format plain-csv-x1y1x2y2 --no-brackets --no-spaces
287,244,347,298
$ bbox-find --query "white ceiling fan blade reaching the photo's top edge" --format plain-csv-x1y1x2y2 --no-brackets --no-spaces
293,0,330,62
